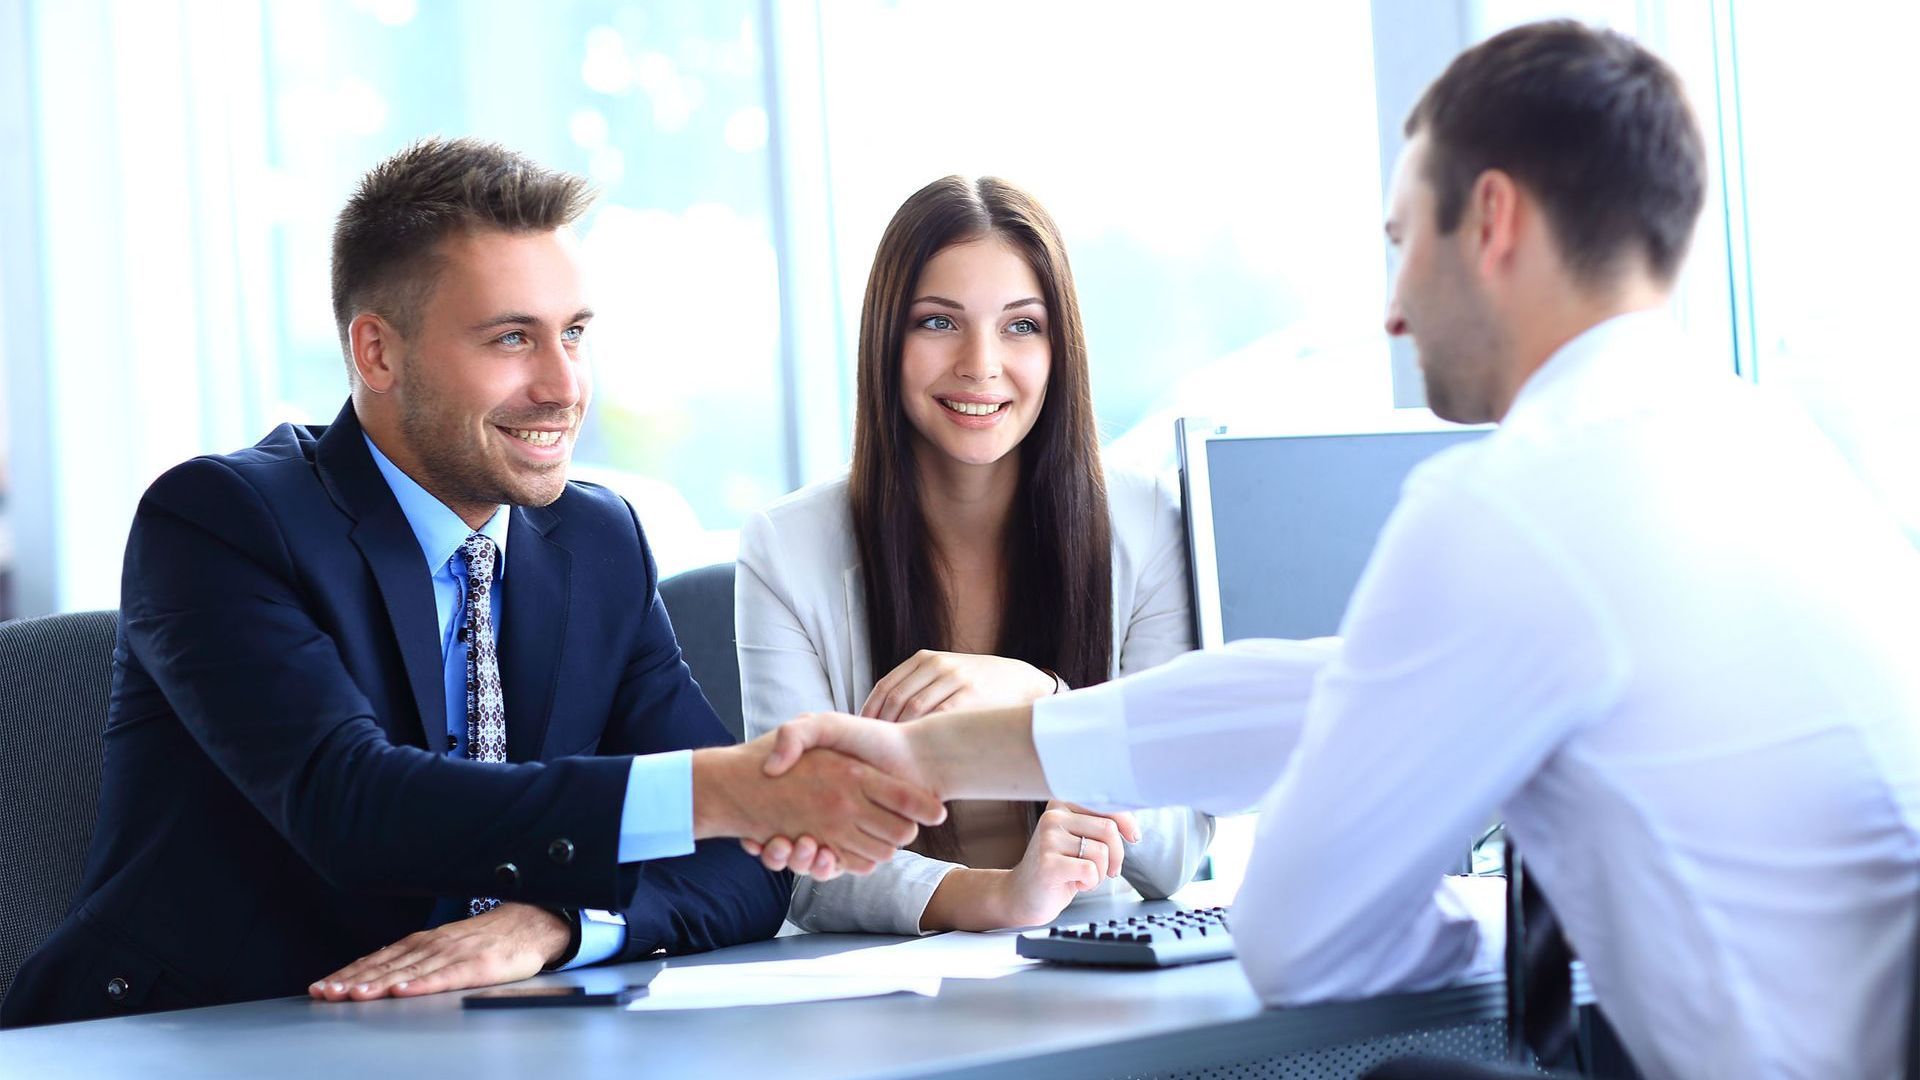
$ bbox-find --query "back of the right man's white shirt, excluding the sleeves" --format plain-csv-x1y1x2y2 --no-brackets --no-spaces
1451,315,1920,1076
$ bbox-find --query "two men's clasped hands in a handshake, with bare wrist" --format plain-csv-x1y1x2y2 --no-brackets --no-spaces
693,707,1046,878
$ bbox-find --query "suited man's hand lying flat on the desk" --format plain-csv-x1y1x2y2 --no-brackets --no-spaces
307,903,572,1001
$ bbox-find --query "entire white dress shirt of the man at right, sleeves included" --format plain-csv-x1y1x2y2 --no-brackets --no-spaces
1035,313,1920,1078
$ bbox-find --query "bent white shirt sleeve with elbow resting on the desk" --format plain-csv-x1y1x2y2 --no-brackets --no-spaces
1235,473,1626,1003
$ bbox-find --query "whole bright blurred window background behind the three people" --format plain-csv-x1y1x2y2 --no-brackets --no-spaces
0,0,1920,619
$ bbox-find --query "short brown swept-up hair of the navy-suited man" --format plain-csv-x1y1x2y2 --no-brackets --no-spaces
334,138,593,361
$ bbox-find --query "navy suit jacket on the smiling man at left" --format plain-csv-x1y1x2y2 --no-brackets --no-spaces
0,404,791,1026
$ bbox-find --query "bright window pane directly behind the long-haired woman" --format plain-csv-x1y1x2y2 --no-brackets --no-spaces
822,0,1390,470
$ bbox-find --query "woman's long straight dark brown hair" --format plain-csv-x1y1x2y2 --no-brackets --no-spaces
849,177,1114,859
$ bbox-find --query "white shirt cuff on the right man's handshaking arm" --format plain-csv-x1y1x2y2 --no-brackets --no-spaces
1033,682,1140,809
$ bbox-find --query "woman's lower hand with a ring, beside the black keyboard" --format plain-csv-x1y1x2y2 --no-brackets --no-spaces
996,801,1140,926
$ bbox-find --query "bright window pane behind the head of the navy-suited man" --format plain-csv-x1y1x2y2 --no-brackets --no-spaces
263,0,787,557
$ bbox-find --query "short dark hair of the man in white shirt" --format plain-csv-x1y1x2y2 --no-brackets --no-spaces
1405,21,1707,282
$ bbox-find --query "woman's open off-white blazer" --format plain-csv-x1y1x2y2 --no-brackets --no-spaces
733,469,1213,934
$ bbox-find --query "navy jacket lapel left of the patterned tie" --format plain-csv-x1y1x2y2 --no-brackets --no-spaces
315,402,447,748
